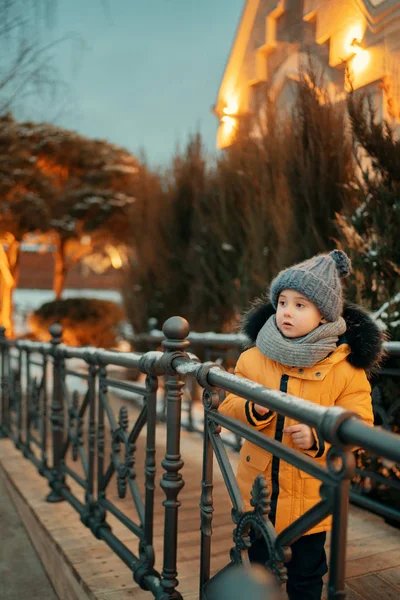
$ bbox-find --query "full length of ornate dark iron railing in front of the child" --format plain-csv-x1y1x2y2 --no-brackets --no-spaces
0,317,400,600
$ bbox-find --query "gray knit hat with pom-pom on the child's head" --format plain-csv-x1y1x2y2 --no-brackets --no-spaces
269,250,351,321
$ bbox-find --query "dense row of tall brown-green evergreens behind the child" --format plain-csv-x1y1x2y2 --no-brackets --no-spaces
125,66,352,331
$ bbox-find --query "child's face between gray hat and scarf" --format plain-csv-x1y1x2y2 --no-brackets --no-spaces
276,290,326,338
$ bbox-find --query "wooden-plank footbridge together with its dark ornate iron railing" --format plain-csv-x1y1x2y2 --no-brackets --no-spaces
0,318,400,600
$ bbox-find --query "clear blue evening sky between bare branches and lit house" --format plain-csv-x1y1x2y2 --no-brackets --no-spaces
34,0,245,164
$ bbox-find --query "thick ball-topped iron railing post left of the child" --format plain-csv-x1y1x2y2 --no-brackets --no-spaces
161,317,189,598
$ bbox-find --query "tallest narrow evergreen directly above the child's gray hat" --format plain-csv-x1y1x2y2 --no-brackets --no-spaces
286,56,354,260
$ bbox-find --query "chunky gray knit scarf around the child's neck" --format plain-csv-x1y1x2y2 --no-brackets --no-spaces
256,315,346,367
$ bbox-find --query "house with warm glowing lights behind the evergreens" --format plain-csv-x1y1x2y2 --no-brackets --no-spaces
214,0,400,148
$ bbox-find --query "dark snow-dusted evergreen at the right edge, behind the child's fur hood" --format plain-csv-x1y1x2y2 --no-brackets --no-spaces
337,92,400,339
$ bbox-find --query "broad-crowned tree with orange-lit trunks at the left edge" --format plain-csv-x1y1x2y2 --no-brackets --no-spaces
0,115,140,334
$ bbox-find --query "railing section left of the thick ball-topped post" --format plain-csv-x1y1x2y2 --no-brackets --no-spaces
0,325,167,599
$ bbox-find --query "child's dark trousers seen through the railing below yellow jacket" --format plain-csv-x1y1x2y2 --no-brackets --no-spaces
249,532,328,600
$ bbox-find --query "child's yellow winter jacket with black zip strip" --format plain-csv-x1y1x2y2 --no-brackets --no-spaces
219,308,381,533
